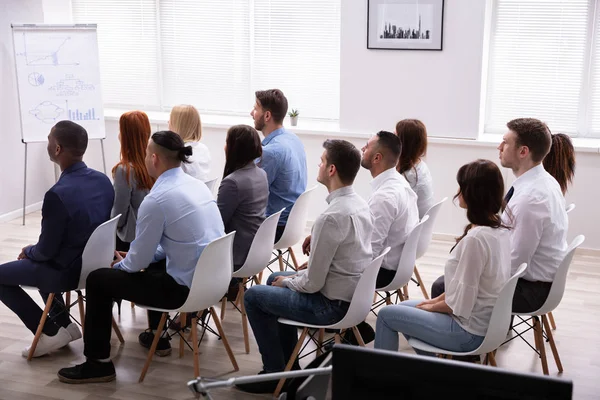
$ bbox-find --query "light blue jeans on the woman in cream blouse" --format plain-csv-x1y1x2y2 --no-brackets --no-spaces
375,300,483,355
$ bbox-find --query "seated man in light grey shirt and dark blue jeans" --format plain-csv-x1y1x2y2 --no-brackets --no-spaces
237,140,373,393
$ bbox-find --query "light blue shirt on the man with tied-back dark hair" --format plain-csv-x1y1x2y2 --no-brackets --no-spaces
113,168,225,287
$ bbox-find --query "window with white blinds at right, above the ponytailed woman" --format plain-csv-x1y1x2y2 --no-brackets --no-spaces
484,0,600,137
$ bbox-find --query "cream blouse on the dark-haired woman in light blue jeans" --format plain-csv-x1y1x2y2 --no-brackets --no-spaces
444,226,511,336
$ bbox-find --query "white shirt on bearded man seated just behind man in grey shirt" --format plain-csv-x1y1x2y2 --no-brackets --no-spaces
369,167,419,271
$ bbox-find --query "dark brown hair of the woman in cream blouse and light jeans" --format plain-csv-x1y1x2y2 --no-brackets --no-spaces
450,159,508,251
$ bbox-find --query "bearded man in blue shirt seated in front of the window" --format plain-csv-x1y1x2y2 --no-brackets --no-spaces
250,89,306,242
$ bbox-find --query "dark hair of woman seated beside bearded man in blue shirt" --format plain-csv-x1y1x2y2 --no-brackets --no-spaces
223,125,262,178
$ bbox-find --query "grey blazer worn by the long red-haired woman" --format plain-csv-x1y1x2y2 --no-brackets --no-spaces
110,165,149,243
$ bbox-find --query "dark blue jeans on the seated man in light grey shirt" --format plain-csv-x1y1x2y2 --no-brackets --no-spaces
244,271,350,372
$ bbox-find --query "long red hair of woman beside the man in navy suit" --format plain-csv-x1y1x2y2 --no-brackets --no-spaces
112,111,154,190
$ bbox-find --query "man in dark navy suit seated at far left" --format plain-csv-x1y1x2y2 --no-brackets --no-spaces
0,121,114,357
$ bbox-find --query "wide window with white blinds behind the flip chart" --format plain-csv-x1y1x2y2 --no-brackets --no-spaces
72,0,341,119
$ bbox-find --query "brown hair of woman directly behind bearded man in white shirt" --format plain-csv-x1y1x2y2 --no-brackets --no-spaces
396,119,427,174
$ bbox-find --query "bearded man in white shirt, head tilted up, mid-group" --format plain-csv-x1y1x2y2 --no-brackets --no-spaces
360,131,419,288
